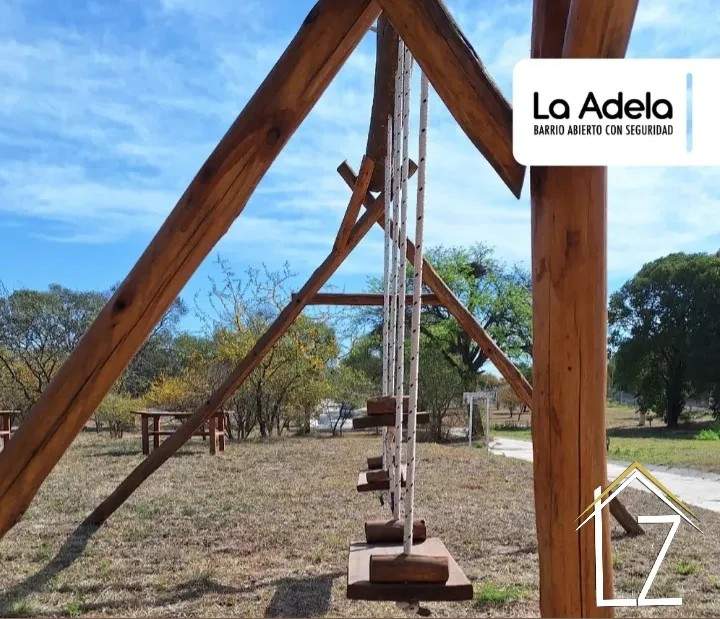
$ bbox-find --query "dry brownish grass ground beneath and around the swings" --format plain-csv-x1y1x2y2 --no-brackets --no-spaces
0,432,720,617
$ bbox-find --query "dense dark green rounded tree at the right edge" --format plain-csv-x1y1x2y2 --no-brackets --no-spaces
609,253,720,428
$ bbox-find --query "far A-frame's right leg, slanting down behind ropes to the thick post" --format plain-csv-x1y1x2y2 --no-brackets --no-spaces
338,162,536,410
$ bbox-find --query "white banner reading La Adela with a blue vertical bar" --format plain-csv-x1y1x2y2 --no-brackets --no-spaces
513,59,720,166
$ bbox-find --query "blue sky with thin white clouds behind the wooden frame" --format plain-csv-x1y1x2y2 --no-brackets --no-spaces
0,0,720,328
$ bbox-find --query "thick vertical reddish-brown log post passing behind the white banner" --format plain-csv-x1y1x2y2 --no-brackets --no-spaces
531,0,636,617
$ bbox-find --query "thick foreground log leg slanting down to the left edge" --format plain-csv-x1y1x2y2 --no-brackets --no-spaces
0,0,379,536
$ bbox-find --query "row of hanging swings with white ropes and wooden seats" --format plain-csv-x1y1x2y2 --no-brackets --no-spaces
347,40,473,605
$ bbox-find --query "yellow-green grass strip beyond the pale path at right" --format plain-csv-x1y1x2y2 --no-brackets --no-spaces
494,406,720,473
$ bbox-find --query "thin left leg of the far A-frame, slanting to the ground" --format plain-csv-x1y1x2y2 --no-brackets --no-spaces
86,195,385,525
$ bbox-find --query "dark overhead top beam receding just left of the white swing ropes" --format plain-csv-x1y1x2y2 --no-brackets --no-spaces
365,15,398,192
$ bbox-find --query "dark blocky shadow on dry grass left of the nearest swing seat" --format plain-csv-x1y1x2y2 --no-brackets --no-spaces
265,572,343,617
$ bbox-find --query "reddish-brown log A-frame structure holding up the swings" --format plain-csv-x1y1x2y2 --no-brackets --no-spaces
0,0,637,616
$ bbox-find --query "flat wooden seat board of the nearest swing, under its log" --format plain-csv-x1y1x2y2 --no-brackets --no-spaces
347,537,473,602
